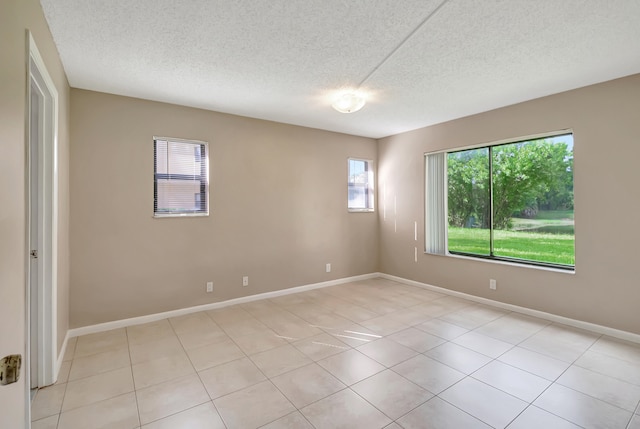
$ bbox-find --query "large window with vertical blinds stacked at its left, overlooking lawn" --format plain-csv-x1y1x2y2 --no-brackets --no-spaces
425,133,575,269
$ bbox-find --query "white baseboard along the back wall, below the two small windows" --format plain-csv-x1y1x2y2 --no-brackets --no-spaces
66,273,381,340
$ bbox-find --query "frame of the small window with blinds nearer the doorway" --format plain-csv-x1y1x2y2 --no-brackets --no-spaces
153,136,210,218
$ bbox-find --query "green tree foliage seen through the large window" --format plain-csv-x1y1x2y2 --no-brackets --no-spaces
447,140,573,229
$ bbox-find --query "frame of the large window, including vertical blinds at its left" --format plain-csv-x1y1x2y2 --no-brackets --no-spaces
424,129,576,274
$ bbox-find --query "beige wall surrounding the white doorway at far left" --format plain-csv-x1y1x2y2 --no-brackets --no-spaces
0,0,69,422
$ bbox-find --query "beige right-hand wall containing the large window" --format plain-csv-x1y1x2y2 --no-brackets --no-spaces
378,75,640,333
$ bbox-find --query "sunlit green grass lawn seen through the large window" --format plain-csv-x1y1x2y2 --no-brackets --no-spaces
449,227,575,265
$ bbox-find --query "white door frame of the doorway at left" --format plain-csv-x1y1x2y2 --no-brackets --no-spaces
25,30,58,395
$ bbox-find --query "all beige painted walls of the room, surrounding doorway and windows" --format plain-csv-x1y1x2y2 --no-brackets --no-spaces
0,0,640,427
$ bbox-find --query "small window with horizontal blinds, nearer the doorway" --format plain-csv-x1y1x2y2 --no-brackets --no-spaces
153,138,209,217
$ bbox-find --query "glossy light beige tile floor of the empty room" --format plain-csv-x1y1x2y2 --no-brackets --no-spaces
32,279,640,429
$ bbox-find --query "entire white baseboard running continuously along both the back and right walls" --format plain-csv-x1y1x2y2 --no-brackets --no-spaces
67,273,640,344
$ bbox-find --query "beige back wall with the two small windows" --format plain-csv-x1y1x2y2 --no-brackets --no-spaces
70,89,378,327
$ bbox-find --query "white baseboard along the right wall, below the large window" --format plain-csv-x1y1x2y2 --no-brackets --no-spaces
379,273,640,343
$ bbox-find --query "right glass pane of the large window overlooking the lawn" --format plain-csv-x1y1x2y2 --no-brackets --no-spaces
492,134,575,265
